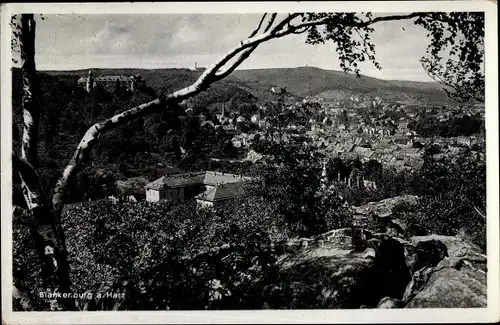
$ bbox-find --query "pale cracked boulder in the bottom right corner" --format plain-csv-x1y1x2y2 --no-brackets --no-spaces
403,235,486,308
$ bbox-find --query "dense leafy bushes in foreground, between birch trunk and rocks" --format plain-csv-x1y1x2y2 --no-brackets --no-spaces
66,197,286,309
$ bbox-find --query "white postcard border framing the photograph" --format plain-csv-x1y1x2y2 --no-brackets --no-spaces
0,1,500,324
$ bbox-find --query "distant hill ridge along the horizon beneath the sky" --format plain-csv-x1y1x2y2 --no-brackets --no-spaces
44,67,453,104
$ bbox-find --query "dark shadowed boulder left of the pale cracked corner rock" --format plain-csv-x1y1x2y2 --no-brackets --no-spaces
270,228,411,309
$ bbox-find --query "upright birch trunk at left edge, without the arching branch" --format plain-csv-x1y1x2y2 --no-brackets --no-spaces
13,14,75,310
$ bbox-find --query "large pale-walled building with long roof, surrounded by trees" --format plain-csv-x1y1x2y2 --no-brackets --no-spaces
145,171,251,206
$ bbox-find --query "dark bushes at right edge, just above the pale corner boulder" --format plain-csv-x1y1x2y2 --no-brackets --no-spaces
396,147,486,250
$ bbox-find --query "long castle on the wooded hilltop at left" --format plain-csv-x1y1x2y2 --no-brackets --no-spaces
77,70,144,93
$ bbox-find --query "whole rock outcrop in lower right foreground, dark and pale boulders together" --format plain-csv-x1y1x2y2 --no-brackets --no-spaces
269,228,486,309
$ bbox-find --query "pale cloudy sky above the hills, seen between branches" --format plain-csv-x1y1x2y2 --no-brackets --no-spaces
31,14,432,81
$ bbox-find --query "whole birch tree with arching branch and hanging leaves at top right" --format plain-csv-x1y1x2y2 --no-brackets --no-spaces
12,12,484,310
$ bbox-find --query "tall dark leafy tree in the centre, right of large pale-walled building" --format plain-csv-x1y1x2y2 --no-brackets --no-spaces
251,97,350,236
